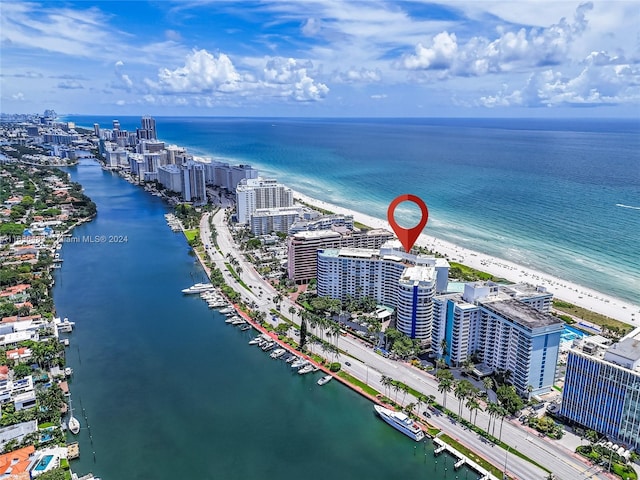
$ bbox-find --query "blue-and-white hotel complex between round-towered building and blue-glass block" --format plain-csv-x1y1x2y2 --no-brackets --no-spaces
431,282,564,395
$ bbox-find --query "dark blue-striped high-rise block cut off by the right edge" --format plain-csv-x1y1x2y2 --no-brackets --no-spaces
560,329,640,450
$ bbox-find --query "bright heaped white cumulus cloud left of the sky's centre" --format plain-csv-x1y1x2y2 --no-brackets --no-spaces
146,49,241,93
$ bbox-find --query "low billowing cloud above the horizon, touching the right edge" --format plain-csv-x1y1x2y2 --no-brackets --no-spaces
479,52,640,107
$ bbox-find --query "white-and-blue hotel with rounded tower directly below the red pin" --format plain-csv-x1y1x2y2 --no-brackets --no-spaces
316,244,449,343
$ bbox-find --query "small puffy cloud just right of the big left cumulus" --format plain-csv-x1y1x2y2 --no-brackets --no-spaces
263,57,329,102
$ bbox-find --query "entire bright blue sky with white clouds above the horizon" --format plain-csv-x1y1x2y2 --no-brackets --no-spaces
0,0,640,118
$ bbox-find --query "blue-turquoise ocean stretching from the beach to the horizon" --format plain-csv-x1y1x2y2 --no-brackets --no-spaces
68,116,640,303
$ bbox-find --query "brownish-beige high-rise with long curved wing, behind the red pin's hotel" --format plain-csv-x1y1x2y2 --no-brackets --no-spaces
287,227,393,284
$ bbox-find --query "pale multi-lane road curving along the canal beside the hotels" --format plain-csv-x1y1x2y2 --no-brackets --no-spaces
200,209,614,480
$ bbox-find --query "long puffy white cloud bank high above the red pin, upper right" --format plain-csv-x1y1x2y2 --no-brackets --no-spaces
399,3,593,77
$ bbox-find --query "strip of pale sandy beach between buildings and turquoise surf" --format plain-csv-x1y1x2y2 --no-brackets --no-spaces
294,191,640,326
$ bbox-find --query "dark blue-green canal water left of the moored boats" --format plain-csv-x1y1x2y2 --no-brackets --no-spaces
53,160,478,480
